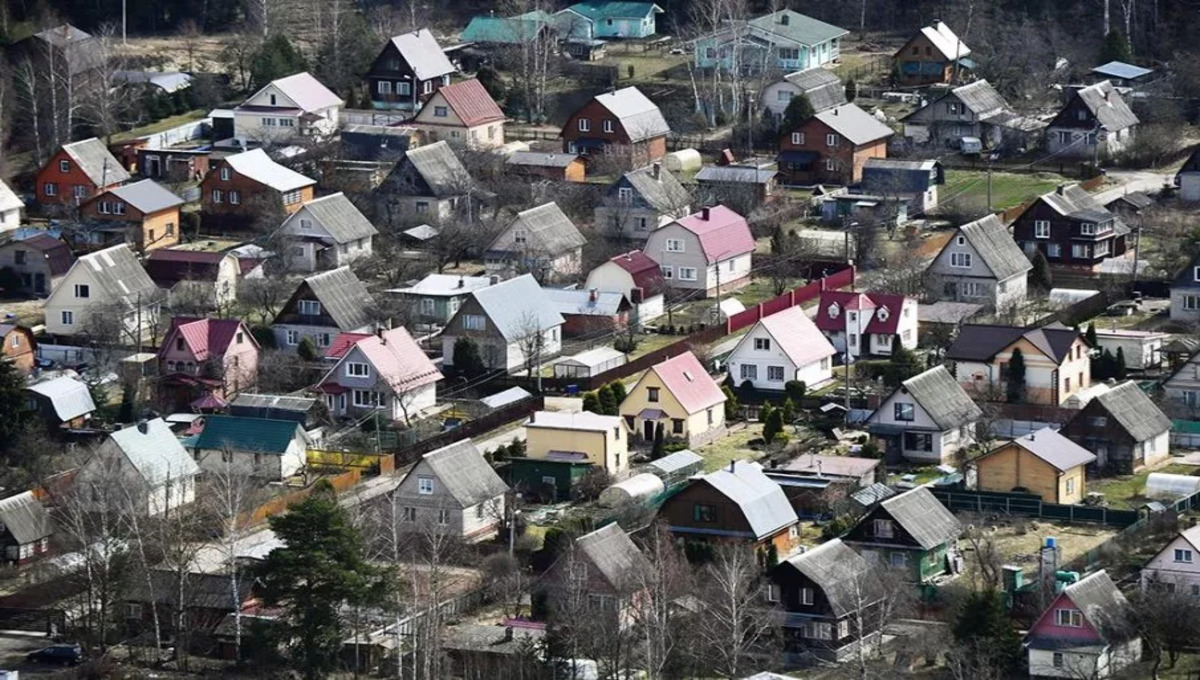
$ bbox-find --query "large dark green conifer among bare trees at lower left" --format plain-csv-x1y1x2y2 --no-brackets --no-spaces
256,493,383,679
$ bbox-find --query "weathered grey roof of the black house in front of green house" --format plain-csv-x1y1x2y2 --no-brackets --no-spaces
780,538,883,616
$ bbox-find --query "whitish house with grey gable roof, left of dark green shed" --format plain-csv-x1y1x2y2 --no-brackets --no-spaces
392,439,510,541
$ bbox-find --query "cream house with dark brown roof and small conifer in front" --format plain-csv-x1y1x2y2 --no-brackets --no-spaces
946,324,1092,407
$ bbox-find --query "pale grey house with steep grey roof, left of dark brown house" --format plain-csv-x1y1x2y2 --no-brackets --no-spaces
925,215,1033,311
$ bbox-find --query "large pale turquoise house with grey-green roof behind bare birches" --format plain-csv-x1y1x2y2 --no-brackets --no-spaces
692,10,850,73
